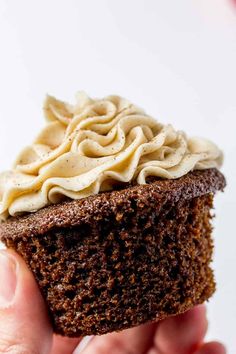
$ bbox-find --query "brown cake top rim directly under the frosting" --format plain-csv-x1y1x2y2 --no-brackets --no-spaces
0,168,226,241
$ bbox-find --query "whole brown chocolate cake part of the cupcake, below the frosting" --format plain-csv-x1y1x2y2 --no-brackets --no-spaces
0,168,225,337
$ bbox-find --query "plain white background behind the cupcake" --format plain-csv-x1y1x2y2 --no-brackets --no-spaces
0,0,236,354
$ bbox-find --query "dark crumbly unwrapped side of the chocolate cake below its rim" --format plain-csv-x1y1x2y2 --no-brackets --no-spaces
4,193,215,337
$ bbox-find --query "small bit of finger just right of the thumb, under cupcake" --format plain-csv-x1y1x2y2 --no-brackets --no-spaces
50,335,81,354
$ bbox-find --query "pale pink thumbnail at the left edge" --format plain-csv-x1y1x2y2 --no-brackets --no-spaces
0,251,17,308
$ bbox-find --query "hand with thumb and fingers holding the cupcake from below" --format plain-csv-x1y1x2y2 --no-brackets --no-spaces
0,251,225,354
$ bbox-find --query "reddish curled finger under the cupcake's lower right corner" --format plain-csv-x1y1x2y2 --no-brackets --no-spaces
154,305,207,354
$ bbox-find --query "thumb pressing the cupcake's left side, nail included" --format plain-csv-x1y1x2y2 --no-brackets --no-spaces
0,250,52,354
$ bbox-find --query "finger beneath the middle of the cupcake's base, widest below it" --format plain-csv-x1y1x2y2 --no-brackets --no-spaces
81,324,157,354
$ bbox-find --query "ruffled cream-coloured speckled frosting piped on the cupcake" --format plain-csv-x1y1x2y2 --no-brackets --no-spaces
0,93,222,218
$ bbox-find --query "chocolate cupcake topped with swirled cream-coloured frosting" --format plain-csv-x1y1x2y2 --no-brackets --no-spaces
0,93,225,337
